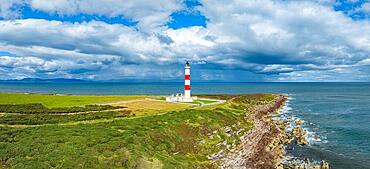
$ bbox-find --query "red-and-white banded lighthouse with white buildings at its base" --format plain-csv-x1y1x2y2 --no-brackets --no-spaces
166,62,197,102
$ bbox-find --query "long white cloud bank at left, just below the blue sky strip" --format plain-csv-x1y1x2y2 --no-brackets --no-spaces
0,19,168,63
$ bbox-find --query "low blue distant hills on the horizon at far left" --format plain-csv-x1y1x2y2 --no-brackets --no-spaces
0,78,90,83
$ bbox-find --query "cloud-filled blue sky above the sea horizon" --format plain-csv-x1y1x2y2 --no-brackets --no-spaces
0,0,370,82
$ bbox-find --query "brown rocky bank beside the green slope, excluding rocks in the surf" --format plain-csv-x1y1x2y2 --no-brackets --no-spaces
220,95,291,169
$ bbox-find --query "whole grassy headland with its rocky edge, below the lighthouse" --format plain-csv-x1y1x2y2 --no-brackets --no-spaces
0,94,327,168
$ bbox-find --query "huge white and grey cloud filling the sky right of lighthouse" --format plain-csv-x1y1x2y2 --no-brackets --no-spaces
200,0,370,80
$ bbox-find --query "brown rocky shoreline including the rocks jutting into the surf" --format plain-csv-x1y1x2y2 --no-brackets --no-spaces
218,95,329,169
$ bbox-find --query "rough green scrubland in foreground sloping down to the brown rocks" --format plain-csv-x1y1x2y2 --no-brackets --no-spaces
0,95,274,169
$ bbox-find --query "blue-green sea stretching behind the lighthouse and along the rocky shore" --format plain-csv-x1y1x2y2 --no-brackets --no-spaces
0,82,370,169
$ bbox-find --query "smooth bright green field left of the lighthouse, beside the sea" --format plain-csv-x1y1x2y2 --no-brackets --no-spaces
0,93,147,108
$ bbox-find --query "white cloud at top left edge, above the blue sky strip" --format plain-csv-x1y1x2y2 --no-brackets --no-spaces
29,0,184,31
